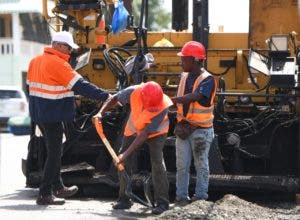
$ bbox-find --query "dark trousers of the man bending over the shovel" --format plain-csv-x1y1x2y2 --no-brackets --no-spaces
119,135,169,205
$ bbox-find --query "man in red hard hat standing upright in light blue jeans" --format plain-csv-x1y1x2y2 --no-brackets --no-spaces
172,41,217,205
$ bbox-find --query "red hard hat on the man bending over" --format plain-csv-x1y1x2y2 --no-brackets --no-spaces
141,81,163,111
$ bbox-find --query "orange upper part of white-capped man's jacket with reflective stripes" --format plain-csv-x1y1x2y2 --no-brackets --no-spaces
27,47,82,100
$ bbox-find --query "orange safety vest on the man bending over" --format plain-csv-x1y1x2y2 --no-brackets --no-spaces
124,86,173,138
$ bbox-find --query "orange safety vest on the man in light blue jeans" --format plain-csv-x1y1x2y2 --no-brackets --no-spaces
177,71,217,128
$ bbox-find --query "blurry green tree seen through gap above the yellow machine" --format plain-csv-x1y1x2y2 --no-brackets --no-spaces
132,0,171,31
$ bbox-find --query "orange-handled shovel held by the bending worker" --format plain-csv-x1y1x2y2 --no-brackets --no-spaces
95,118,151,207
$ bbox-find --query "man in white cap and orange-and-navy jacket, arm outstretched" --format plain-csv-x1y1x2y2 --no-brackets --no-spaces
27,31,109,205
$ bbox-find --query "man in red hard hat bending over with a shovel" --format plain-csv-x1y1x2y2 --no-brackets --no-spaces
95,81,173,214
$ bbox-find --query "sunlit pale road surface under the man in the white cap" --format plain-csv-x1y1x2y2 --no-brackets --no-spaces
0,133,154,220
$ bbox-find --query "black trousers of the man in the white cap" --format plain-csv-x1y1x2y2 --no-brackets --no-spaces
38,122,64,196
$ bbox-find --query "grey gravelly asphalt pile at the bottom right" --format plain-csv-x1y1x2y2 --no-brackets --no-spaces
157,194,300,220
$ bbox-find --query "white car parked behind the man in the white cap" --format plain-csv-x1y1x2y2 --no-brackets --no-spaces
0,86,29,131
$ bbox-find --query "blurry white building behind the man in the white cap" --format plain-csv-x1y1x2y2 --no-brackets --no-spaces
0,0,51,90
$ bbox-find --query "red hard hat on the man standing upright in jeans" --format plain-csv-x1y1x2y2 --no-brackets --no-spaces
177,41,206,60
